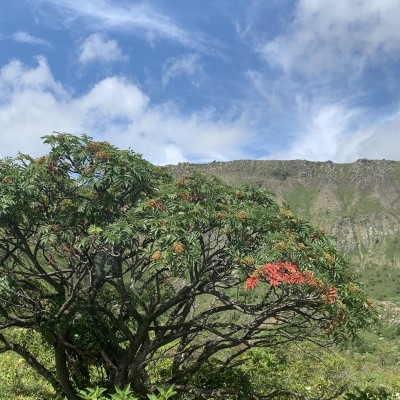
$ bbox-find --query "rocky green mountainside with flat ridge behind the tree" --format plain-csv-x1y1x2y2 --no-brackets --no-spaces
168,159,400,300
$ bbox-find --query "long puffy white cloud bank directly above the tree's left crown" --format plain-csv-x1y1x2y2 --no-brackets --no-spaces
0,58,250,164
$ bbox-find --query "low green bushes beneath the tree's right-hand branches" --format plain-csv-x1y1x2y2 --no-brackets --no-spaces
181,343,400,400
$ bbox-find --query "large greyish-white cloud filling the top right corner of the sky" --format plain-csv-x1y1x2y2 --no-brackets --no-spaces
258,0,400,76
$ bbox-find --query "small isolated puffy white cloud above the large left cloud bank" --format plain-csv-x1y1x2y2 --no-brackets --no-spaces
79,33,126,64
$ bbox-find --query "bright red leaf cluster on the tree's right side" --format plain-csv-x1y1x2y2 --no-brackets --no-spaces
244,262,337,303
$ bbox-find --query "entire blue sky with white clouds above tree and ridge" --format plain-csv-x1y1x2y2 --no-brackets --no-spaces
0,0,400,164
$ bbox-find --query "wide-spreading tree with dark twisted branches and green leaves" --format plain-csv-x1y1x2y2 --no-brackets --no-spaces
0,134,374,399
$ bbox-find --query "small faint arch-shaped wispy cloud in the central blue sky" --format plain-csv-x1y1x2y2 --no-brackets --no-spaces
162,53,203,86
